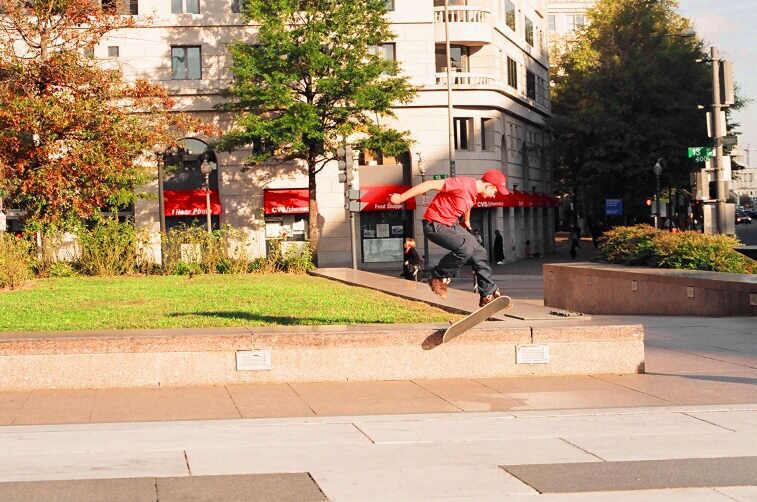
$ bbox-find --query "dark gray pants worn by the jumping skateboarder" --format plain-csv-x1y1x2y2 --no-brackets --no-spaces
423,220,497,296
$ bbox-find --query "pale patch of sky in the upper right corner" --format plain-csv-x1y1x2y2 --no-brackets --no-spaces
678,0,757,168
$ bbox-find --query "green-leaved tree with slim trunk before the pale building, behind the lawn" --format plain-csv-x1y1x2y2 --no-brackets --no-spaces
219,0,415,253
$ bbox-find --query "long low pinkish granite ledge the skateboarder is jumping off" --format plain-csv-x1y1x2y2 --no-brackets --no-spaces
0,321,644,391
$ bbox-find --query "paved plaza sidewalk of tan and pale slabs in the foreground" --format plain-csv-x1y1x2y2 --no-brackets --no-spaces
0,248,757,502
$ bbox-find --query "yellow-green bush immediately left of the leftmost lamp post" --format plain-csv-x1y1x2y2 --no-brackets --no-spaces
76,215,147,276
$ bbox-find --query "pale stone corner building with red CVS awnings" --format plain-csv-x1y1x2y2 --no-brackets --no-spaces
95,0,554,268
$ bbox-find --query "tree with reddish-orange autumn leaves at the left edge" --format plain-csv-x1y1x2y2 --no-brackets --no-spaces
0,0,211,226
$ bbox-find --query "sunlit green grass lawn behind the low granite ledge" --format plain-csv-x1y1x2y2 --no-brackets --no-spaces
0,274,460,331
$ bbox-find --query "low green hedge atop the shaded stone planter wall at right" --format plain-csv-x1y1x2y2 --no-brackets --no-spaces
599,225,757,274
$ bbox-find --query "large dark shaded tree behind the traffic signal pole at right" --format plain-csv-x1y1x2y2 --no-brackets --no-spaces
552,0,712,224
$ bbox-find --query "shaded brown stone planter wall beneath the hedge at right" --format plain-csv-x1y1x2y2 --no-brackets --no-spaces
544,263,757,316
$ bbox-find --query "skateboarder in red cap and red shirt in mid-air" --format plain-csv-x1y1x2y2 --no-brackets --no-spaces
389,169,510,307
